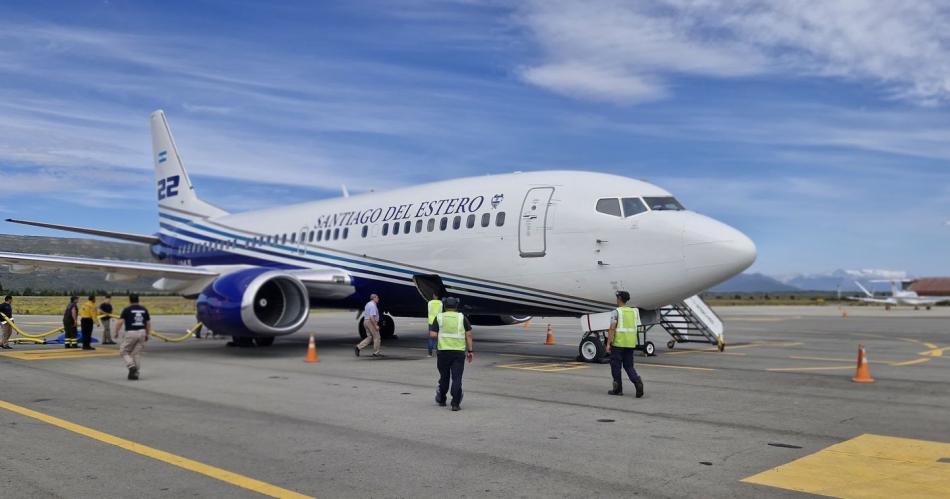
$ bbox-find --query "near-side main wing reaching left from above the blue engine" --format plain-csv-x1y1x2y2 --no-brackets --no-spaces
0,252,220,281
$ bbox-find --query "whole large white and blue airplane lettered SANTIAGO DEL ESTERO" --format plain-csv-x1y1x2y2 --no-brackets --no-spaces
0,110,756,356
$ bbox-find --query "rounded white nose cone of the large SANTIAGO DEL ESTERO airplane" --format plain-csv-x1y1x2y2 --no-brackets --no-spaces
683,214,757,287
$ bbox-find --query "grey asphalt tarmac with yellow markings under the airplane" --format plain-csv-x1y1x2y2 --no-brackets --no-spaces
0,304,950,498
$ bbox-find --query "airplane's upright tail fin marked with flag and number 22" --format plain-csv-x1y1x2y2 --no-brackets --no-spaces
151,110,228,218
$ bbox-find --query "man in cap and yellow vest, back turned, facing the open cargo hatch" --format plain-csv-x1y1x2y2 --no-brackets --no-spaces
429,296,473,411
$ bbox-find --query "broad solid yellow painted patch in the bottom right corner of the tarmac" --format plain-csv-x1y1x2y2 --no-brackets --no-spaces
742,434,950,498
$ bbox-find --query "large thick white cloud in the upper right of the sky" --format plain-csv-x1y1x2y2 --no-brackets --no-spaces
516,0,950,104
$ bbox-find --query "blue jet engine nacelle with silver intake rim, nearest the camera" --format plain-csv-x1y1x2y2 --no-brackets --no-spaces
197,269,310,336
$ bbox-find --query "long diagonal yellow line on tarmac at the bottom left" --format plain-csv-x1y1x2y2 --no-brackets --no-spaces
0,400,312,499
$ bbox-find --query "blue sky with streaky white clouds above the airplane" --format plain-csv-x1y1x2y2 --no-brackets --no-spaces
0,0,950,276
